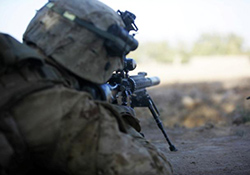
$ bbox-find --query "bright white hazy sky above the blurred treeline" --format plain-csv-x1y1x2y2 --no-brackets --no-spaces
0,0,250,47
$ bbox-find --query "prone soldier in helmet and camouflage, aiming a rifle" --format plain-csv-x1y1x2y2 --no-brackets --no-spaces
0,0,172,175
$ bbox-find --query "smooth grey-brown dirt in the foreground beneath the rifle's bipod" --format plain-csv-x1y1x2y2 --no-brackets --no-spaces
144,125,250,175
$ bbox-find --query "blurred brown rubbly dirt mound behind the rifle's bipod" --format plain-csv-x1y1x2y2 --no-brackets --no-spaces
136,79,250,128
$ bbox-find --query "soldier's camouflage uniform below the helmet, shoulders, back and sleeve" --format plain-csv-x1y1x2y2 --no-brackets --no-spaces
0,0,172,175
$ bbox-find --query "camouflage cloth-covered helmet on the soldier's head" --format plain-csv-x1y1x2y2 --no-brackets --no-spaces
23,0,138,84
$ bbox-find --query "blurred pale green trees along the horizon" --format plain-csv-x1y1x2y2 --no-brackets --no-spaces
129,33,250,63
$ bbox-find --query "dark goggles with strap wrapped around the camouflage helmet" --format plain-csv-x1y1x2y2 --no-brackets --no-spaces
46,2,138,57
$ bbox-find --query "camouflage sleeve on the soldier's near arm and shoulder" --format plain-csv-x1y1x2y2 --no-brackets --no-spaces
12,88,172,175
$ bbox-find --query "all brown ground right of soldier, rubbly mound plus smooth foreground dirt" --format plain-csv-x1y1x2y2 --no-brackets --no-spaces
136,79,250,175
